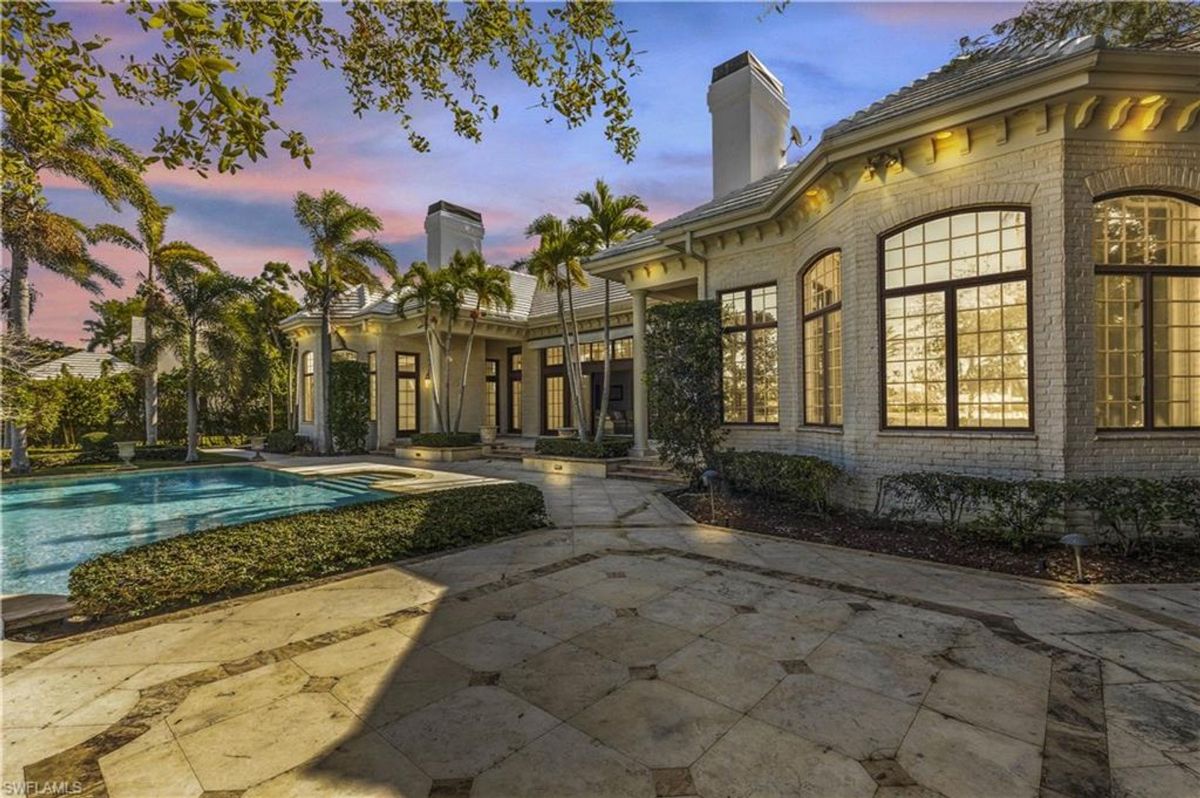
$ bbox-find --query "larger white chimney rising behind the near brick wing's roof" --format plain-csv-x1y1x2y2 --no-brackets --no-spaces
708,50,788,198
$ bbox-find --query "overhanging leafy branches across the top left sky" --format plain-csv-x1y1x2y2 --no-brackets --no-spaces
2,0,638,188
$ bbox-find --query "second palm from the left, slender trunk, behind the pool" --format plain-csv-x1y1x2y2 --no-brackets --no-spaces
95,203,217,446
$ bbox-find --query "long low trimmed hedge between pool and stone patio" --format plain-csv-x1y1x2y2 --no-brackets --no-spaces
70,482,546,617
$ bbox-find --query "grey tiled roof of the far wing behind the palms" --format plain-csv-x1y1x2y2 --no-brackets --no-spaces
283,271,630,326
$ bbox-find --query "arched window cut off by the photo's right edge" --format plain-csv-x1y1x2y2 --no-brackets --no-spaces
1092,194,1200,430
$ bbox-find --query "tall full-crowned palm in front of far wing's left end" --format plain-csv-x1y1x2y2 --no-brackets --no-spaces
293,191,396,455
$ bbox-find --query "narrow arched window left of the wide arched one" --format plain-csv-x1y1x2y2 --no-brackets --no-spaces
800,251,841,426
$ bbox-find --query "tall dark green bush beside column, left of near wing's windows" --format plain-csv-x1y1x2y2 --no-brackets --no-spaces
644,300,725,479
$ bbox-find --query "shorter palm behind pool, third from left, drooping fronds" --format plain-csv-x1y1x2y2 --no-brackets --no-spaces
160,266,248,463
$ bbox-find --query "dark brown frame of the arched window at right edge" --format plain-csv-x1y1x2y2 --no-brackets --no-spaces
1087,188,1200,433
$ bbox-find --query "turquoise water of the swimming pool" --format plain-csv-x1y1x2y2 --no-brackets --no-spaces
0,466,394,595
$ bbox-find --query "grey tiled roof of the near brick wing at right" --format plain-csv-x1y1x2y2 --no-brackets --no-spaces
590,36,1194,263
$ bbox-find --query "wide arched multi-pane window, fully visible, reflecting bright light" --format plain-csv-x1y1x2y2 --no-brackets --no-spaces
881,209,1033,430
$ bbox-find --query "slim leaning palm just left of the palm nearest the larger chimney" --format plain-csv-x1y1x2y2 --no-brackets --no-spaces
526,214,587,440
